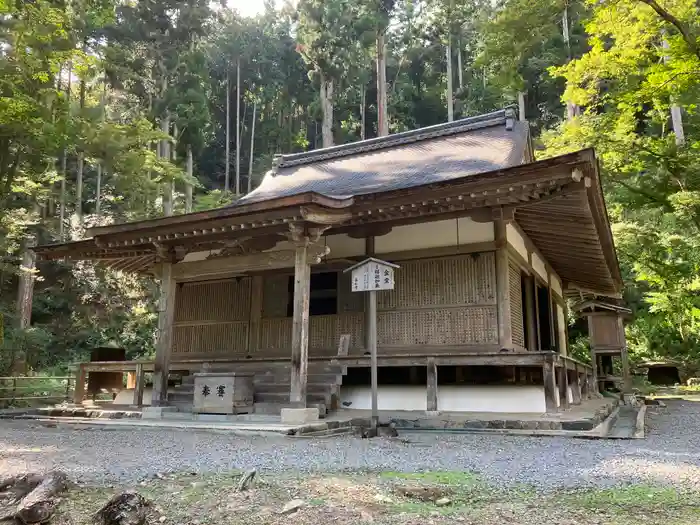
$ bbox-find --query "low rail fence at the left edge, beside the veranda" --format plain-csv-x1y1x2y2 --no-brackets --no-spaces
0,376,75,407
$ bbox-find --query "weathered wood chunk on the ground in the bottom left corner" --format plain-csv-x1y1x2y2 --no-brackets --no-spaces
0,470,68,525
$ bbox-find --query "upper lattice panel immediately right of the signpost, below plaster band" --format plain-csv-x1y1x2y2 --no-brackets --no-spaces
377,252,496,310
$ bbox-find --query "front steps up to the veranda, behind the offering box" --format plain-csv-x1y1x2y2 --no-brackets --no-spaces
168,362,347,417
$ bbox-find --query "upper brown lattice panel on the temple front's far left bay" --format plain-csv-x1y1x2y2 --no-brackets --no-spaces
175,277,251,323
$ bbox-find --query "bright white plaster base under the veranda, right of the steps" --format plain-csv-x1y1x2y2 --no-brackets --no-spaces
340,385,546,414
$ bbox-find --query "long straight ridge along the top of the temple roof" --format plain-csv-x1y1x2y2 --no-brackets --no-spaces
272,108,515,169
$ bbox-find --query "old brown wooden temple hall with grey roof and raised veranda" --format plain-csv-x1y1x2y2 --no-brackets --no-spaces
36,110,624,415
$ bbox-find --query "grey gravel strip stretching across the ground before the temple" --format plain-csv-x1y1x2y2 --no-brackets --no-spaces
0,401,700,490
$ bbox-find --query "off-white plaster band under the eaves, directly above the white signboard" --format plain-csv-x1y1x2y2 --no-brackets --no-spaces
374,218,493,254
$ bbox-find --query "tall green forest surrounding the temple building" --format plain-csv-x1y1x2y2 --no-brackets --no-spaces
0,0,700,375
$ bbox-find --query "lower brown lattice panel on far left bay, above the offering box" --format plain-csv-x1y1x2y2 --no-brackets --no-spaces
173,321,248,357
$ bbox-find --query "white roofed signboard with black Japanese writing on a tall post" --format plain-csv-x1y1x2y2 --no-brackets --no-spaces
345,257,398,437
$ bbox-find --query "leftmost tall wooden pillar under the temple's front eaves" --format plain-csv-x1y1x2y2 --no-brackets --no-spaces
151,262,175,407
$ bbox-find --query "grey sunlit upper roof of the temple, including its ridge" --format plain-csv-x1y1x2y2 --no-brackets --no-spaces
234,110,528,205
